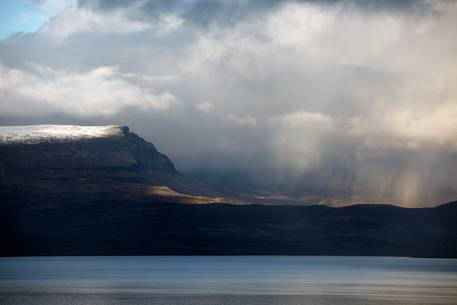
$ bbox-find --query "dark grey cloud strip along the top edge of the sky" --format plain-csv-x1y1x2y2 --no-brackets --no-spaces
78,0,434,26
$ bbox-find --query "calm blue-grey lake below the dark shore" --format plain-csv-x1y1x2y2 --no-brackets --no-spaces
0,256,457,305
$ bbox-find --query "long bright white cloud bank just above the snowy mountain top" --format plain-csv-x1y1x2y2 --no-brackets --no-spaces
0,66,176,117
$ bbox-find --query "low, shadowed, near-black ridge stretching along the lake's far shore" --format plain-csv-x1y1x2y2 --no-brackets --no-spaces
0,194,457,258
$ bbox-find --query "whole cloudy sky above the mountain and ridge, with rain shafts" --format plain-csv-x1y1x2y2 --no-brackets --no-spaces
0,0,457,206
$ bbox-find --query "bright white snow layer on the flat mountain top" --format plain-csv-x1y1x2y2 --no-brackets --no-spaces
0,125,125,144
